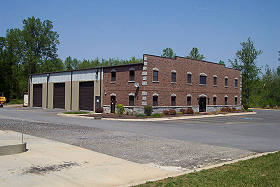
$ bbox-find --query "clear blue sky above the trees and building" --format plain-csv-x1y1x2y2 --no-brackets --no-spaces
0,0,280,68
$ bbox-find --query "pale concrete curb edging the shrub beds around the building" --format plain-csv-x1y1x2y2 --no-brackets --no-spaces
57,112,256,122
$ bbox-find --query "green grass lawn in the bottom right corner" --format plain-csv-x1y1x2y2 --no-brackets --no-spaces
138,152,280,187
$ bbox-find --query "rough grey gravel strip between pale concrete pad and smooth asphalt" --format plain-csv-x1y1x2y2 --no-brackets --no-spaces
0,119,255,169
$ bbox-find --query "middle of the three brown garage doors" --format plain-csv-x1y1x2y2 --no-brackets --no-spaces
53,83,65,109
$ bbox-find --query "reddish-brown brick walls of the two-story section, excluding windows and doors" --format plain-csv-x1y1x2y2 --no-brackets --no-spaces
104,55,241,109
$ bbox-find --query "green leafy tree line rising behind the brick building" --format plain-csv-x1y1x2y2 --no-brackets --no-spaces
0,17,280,108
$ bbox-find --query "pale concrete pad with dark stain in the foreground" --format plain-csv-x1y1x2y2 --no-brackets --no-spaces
0,131,178,187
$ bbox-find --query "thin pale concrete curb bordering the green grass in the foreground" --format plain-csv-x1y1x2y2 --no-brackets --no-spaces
126,151,278,187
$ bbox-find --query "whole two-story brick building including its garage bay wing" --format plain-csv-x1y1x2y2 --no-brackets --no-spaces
29,54,242,113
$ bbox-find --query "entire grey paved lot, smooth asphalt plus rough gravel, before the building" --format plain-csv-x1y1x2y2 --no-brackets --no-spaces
0,108,280,168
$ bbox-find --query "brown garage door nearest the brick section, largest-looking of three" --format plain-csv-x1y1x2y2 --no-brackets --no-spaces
79,81,94,111
